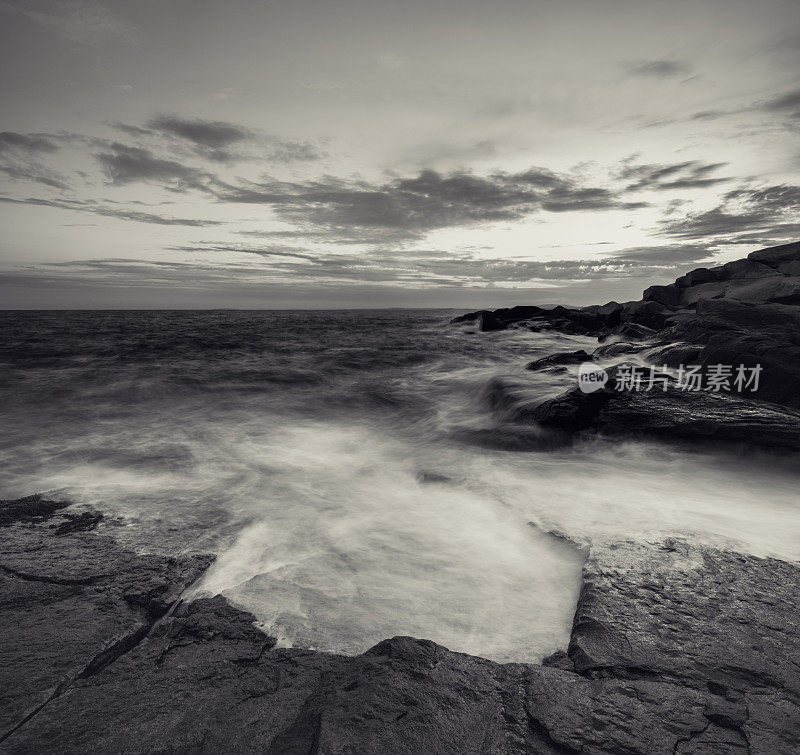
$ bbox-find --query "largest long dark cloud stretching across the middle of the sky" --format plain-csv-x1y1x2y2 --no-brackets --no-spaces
217,168,645,239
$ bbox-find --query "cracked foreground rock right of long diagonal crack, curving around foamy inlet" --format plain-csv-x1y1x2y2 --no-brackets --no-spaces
0,508,800,755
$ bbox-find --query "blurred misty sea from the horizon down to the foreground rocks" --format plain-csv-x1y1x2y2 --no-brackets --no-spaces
0,311,800,661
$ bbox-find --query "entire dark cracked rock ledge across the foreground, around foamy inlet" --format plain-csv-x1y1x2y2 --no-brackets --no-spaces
0,497,800,755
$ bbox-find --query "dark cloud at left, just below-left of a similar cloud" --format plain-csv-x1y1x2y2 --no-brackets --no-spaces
95,142,210,190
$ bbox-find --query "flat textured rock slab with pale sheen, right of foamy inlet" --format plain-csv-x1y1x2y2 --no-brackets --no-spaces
569,540,800,753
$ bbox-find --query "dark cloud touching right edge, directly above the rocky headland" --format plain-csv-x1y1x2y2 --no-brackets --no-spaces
660,184,800,244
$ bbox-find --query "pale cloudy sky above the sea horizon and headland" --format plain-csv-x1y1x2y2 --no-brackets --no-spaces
0,0,800,309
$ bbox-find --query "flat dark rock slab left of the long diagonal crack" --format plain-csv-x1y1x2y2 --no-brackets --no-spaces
0,497,212,747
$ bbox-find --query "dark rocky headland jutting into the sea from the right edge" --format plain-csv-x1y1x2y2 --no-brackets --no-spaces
462,242,800,452
